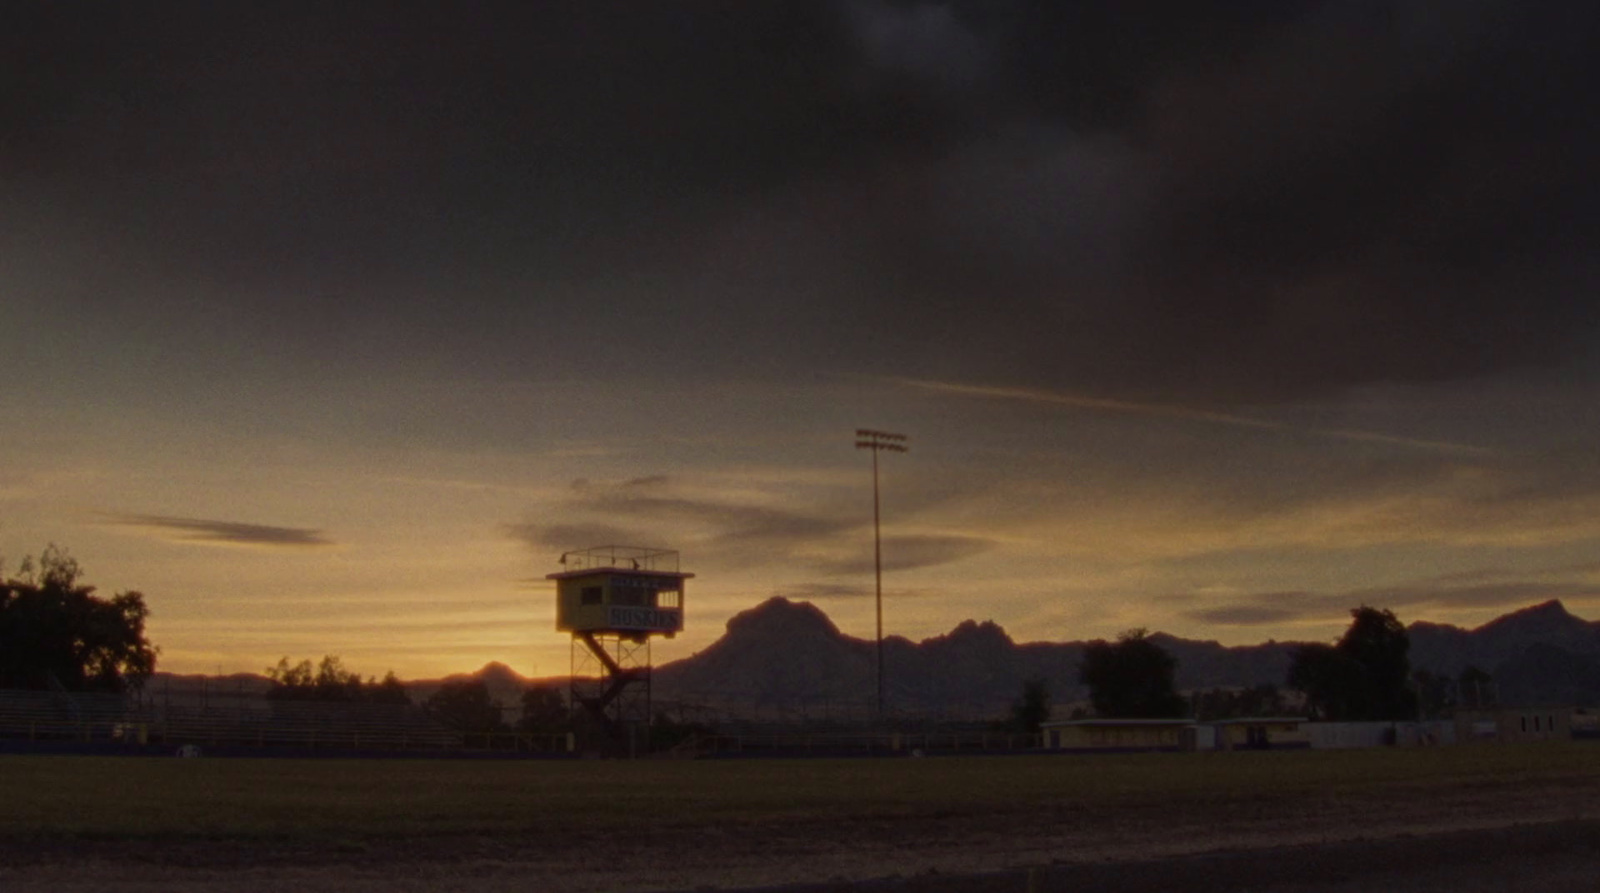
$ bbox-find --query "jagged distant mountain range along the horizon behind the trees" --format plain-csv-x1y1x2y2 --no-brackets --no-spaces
150,597,1600,720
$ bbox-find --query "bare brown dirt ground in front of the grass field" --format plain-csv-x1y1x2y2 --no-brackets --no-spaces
0,779,1600,893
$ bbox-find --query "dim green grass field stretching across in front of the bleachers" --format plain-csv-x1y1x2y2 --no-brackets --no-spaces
0,743,1600,842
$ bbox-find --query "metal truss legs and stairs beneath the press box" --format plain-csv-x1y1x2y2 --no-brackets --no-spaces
571,631,650,743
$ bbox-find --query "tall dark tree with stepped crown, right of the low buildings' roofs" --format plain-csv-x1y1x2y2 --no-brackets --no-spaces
1288,605,1418,720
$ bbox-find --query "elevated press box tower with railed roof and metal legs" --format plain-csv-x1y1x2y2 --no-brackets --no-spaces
546,546,694,744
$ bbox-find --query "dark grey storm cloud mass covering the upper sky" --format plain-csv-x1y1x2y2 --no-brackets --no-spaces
0,0,1600,400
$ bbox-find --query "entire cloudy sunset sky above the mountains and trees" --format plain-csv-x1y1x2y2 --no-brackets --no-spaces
0,0,1600,677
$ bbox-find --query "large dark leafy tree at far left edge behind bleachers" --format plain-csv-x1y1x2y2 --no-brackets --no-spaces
0,544,160,691
